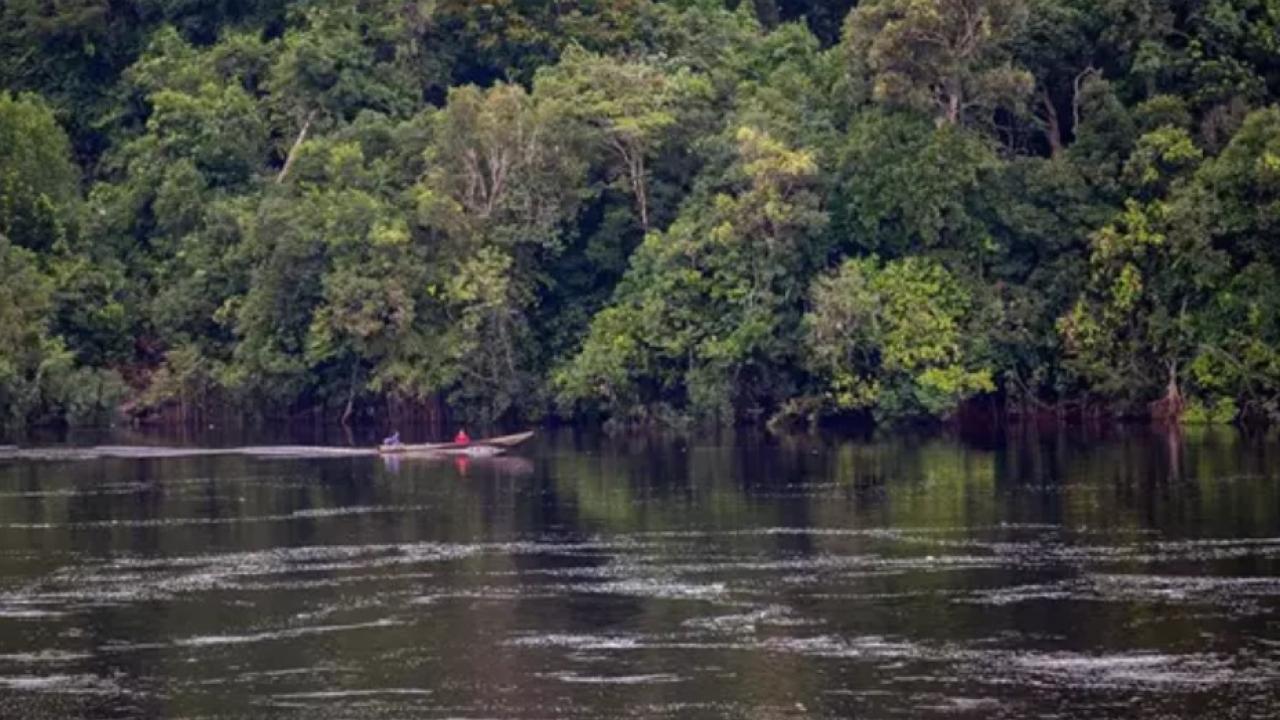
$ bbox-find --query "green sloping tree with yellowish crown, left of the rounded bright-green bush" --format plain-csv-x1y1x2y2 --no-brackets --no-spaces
556,127,826,418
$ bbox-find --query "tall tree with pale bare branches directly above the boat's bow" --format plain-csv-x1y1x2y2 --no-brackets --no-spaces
416,85,585,419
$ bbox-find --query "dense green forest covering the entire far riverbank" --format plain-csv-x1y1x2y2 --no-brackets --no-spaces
0,0,1280,428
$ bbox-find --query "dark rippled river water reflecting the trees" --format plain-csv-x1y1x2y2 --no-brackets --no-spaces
0,429,1280,720
